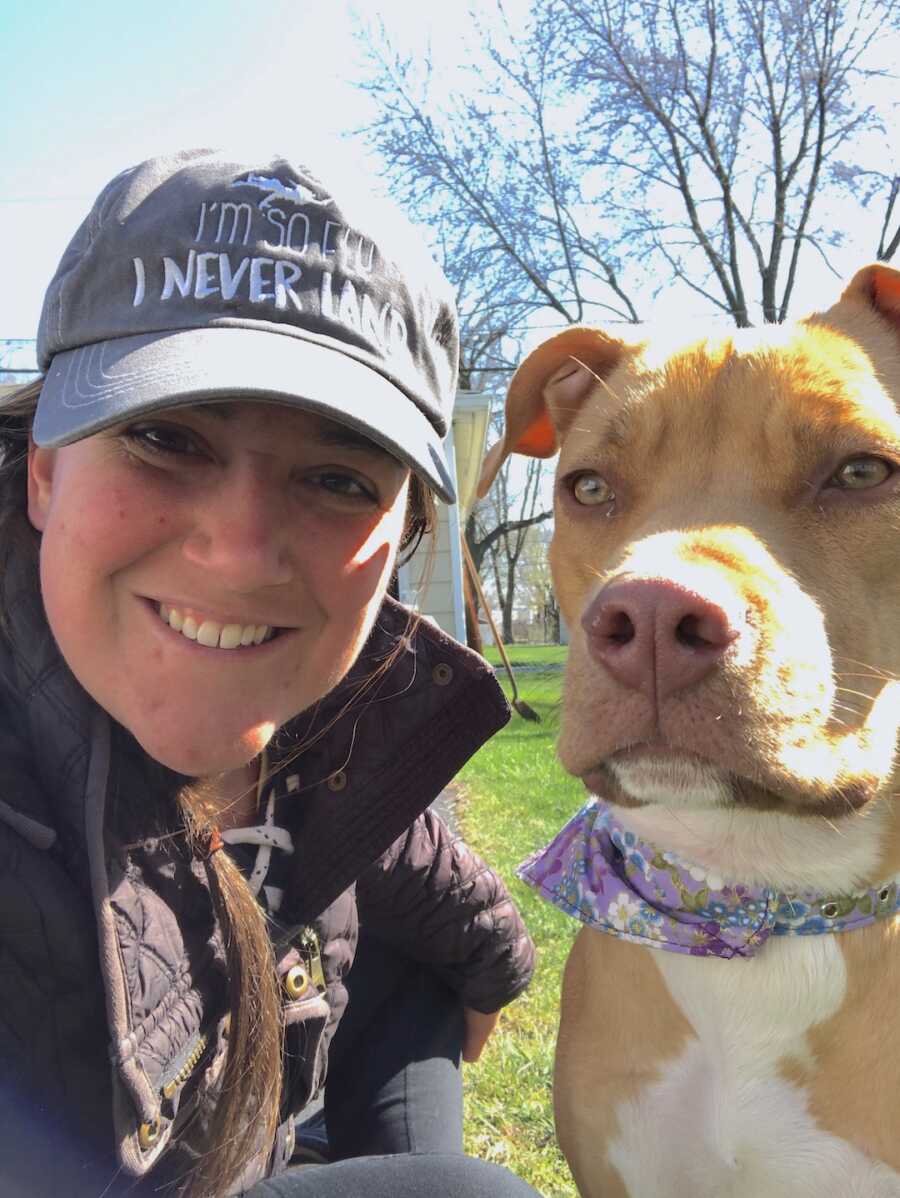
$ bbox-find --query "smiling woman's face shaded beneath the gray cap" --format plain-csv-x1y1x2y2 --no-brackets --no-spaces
29,403,409,776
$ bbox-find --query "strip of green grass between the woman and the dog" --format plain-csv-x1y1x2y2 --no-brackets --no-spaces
459,661,584,1198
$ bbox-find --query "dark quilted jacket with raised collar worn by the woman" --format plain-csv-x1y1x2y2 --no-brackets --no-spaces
0,555,532,1198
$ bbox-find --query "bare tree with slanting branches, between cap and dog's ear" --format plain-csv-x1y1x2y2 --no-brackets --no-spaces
361,14,638,327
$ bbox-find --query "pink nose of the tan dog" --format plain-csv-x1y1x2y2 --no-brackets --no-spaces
581,579,738,698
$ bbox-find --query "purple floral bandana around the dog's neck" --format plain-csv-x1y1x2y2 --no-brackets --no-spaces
517,798,900,957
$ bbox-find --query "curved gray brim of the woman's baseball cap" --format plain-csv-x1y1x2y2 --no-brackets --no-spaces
32,326,457,503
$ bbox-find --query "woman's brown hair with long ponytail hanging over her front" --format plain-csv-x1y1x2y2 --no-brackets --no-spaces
0,380,435,1198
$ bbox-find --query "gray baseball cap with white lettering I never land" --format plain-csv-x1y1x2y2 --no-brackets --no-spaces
32,150,459,502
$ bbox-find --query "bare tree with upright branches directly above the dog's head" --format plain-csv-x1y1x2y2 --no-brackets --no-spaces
558,0,898,326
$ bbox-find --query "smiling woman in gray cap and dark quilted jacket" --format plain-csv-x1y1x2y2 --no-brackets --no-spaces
0,152,539,1198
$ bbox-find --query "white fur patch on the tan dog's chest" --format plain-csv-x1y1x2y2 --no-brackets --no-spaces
609,936,900,1198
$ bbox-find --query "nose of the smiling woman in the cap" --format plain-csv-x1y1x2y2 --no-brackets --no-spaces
183,467,295,592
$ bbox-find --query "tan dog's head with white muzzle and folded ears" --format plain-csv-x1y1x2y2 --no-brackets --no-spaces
481,266,900,833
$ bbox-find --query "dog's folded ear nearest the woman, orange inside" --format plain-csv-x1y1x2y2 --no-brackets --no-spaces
478,325,626,498
